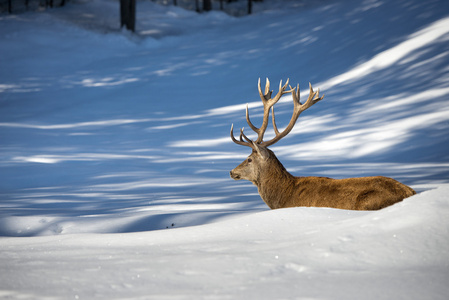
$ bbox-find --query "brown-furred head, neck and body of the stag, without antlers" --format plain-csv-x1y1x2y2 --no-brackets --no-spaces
230,146,416,210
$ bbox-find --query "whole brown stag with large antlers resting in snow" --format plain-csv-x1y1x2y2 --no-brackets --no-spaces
230,78,416,210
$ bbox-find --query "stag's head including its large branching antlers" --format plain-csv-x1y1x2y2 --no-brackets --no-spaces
230,78,324,186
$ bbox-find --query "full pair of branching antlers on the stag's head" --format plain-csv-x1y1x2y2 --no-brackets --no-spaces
231,78,324,149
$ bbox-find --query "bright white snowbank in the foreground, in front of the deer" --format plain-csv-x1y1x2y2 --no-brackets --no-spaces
0,185,449,300
